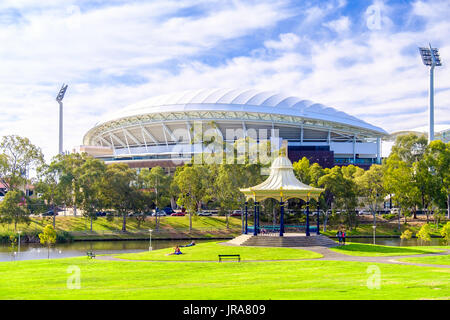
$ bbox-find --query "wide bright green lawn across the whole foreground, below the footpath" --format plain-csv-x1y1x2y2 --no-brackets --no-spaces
0,258,450,299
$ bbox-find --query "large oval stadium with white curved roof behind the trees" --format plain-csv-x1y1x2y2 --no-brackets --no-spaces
79,89,388,171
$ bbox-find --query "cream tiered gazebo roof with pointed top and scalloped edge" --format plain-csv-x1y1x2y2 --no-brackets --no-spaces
240,156,324,202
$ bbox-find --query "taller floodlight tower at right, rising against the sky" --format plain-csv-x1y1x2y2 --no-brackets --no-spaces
419,44,442,143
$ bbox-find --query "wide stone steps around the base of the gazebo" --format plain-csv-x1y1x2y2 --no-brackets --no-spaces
234,234,338,247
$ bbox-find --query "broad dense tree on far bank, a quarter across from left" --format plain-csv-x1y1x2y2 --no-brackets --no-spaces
101,163,138,232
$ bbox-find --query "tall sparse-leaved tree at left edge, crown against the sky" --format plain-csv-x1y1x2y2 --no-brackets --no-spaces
0,135,44,190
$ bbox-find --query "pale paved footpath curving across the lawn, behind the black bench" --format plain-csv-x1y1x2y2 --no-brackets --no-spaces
97,247,450,268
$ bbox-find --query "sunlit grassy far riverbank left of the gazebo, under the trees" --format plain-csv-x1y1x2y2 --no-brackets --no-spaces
0,216,241,243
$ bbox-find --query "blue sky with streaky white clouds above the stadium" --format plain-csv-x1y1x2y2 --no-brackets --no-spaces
0,0,450,160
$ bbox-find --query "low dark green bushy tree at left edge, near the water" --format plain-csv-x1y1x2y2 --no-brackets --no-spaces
0,190,31,232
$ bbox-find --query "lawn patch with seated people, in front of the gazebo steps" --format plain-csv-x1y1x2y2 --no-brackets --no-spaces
116,242,322,261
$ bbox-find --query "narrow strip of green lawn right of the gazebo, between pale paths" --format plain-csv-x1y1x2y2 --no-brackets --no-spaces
330,243,445,257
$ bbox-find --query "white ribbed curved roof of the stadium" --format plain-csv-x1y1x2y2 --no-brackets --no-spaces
96,89,388,135
